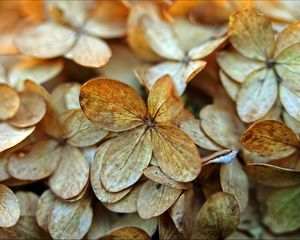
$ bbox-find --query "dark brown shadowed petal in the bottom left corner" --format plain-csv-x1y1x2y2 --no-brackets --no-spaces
0,216,50,240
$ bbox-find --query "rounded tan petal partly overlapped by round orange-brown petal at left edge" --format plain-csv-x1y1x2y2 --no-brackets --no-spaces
8,91,46,128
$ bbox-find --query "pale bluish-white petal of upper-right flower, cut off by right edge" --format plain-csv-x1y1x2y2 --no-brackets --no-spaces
279,84,300,121
